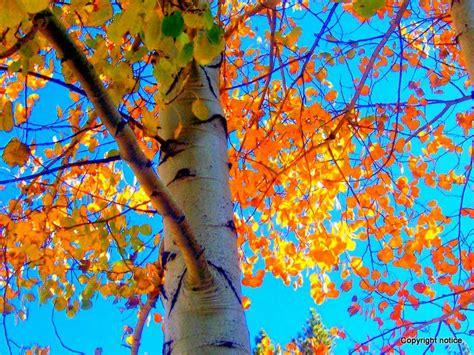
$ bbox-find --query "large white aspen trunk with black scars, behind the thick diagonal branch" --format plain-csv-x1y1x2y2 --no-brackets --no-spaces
158,65,250,355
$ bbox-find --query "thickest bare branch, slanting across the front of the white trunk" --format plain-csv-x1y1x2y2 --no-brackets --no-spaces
32,9,212,288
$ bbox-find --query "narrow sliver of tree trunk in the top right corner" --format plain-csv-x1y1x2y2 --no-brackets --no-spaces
451,0,474,84
